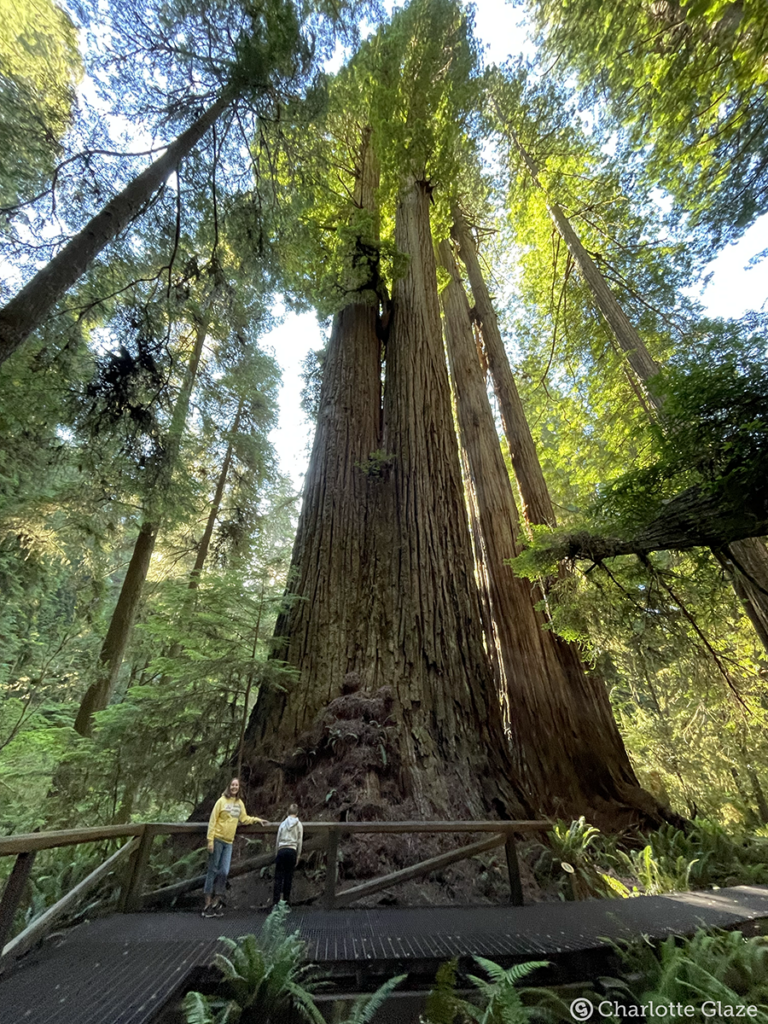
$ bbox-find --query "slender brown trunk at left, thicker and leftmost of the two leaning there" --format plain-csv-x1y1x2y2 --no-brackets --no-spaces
75,313,209,736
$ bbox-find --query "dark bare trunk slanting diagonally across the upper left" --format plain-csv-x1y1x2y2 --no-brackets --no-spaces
0,90,234,364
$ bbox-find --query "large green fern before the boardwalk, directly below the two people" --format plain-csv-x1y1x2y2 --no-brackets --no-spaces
184,903,325,1024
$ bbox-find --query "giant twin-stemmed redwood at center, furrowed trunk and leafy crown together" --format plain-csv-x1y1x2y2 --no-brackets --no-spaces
246,0,524,816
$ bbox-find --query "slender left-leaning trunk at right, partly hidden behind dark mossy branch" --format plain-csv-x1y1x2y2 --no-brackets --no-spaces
508,128,768,651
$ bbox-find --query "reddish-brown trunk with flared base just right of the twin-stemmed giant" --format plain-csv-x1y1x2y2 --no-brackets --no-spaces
439,234,663,823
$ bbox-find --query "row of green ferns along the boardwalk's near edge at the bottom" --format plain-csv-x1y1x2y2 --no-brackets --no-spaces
183,904,768,1024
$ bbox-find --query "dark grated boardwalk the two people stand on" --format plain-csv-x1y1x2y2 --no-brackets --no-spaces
0,886,768,1024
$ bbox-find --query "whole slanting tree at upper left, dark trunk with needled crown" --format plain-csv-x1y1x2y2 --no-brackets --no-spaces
0,0,358,362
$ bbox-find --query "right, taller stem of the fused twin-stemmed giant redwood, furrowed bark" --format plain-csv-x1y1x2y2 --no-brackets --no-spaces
372,180,524,815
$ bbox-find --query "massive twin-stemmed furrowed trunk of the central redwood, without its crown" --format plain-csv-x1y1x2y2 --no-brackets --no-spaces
245,172,526,817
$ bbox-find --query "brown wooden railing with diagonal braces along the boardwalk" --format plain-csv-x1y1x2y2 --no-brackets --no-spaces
0,821,551,958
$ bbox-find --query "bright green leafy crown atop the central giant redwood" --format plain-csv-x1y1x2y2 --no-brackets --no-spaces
268,0,479,315
